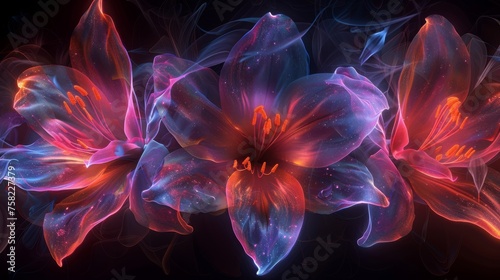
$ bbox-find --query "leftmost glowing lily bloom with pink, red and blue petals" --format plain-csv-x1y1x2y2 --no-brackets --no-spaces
2,0,192,266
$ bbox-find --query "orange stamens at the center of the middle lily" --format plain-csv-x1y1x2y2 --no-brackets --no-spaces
233,105,288,177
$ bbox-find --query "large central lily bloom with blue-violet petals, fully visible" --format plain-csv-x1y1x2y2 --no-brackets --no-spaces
143,13,389,275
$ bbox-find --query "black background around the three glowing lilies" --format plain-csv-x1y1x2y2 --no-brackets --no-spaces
0,0,500,280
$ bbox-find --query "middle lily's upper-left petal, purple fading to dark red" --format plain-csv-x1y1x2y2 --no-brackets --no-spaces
155,56,243,162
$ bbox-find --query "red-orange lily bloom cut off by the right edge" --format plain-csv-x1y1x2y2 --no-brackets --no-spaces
390,15,500,238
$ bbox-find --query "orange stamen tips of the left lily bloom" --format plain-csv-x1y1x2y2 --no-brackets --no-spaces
63,85,102,149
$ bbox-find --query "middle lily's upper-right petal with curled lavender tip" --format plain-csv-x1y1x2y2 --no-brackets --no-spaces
273,67,388,167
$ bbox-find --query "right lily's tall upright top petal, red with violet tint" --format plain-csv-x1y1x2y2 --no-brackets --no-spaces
396,15,471,148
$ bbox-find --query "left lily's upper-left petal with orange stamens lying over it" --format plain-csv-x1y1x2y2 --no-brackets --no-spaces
14,66,125,154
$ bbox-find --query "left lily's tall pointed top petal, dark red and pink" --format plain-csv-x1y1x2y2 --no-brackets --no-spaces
69,0,141,139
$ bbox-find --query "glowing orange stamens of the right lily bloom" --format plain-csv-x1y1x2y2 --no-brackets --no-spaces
419,97,476,163
